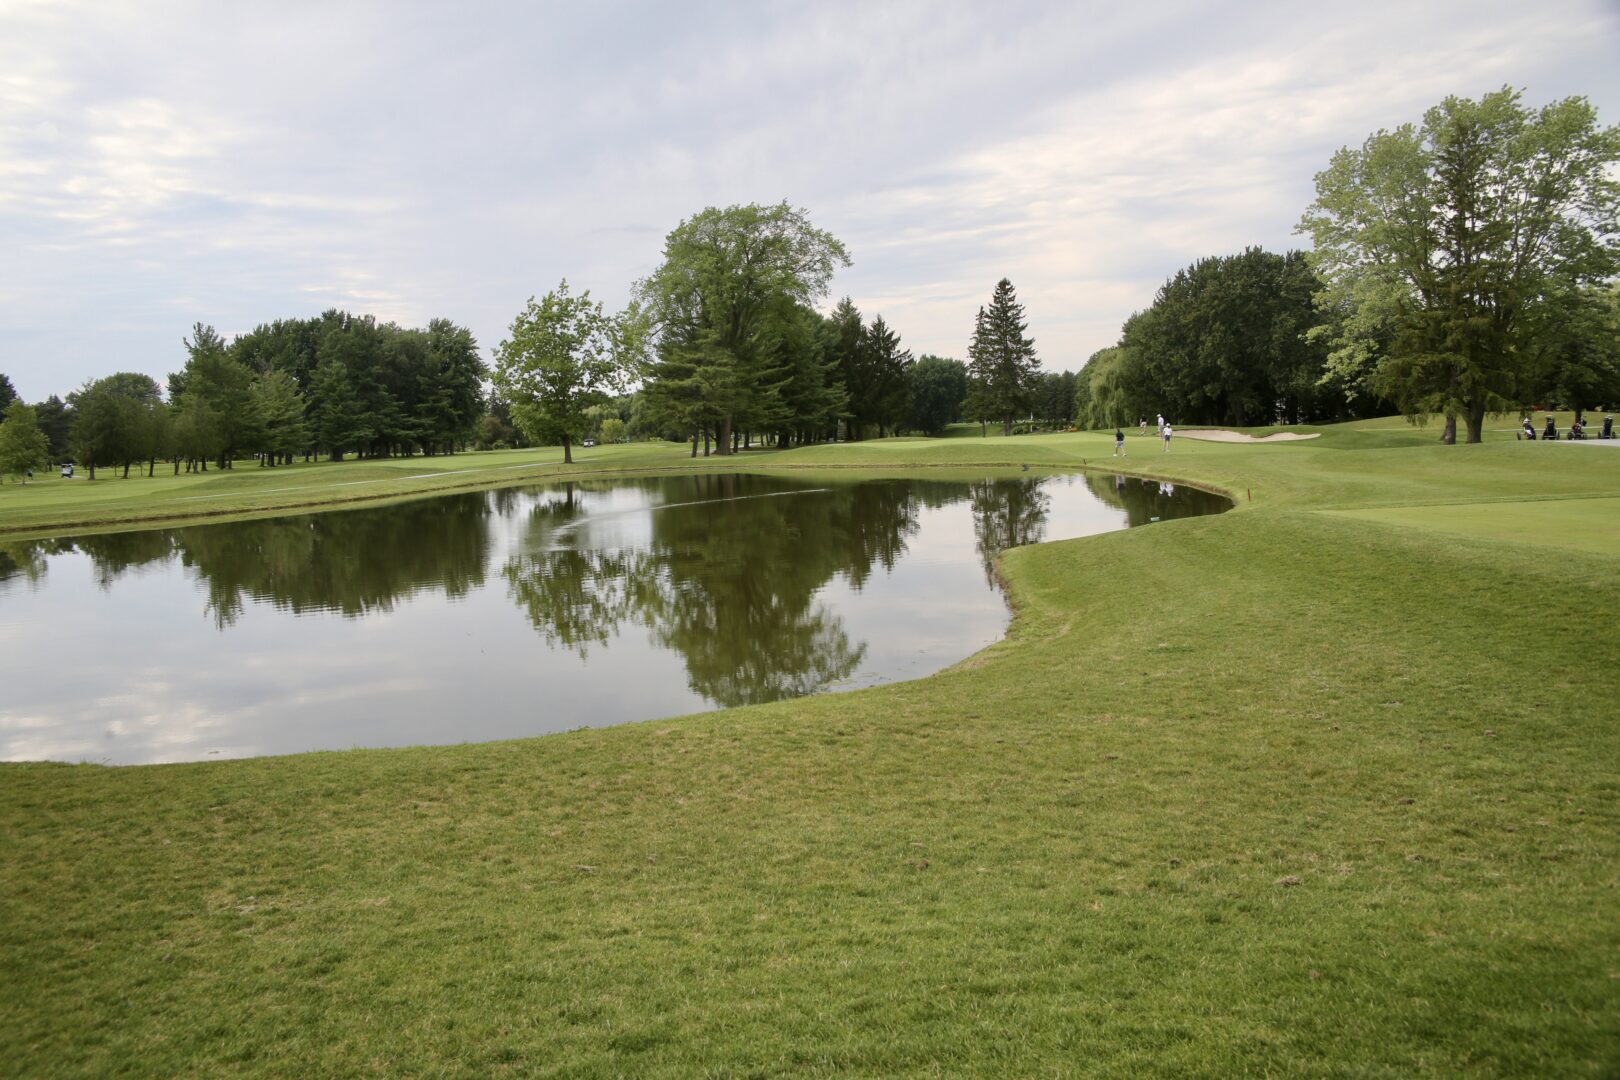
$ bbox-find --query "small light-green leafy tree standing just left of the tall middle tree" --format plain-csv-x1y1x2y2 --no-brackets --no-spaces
494,280,632,463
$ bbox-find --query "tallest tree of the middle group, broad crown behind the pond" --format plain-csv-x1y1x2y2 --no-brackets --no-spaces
637,202,849,453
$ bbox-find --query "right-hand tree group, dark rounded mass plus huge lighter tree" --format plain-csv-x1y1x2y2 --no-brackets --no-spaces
1076,87,1620,442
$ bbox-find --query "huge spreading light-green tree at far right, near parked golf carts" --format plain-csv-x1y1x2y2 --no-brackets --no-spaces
1299,87,1620,442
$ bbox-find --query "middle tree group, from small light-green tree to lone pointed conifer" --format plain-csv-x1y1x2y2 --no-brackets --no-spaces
494,202,1074,460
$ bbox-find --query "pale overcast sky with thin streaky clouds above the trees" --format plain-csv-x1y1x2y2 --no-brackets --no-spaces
0,0,1620,402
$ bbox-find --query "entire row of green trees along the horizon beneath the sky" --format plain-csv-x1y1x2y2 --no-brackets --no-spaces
22,87,1620,474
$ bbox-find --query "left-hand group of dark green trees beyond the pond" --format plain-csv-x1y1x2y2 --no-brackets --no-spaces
0,311,486,478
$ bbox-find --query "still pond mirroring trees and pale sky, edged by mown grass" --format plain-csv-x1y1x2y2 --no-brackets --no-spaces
0,474,1228,764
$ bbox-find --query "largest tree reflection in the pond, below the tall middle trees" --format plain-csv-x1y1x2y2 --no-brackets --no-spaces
502,474,917,706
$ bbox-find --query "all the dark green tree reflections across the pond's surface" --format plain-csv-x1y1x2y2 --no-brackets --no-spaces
0,474,1223,722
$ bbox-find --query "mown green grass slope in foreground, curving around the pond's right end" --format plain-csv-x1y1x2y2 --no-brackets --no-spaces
0,429,1620,1077
